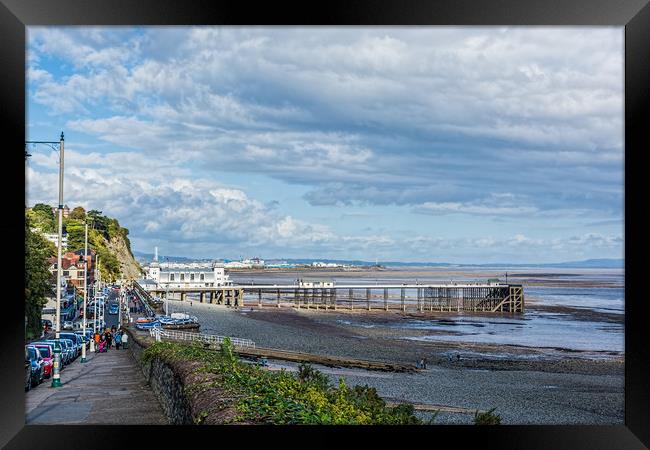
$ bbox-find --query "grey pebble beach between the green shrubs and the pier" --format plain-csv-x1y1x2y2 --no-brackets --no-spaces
157,300,624,425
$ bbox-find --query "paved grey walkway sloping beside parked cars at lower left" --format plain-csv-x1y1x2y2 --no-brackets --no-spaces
25,348,168,425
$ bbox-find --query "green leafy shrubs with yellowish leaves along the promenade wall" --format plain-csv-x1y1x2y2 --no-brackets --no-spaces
143,339,421,424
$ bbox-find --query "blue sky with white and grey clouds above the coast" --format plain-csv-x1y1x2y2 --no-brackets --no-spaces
26,27,624,263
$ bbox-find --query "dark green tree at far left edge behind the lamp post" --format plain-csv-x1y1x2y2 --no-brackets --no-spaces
25,217,53,338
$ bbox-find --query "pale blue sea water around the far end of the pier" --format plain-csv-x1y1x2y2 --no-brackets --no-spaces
231,267,625,353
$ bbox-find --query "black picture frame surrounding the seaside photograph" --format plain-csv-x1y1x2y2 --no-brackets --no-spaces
0,0,650,449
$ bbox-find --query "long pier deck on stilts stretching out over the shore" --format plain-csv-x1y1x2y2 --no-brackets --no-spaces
134,282,524,313
